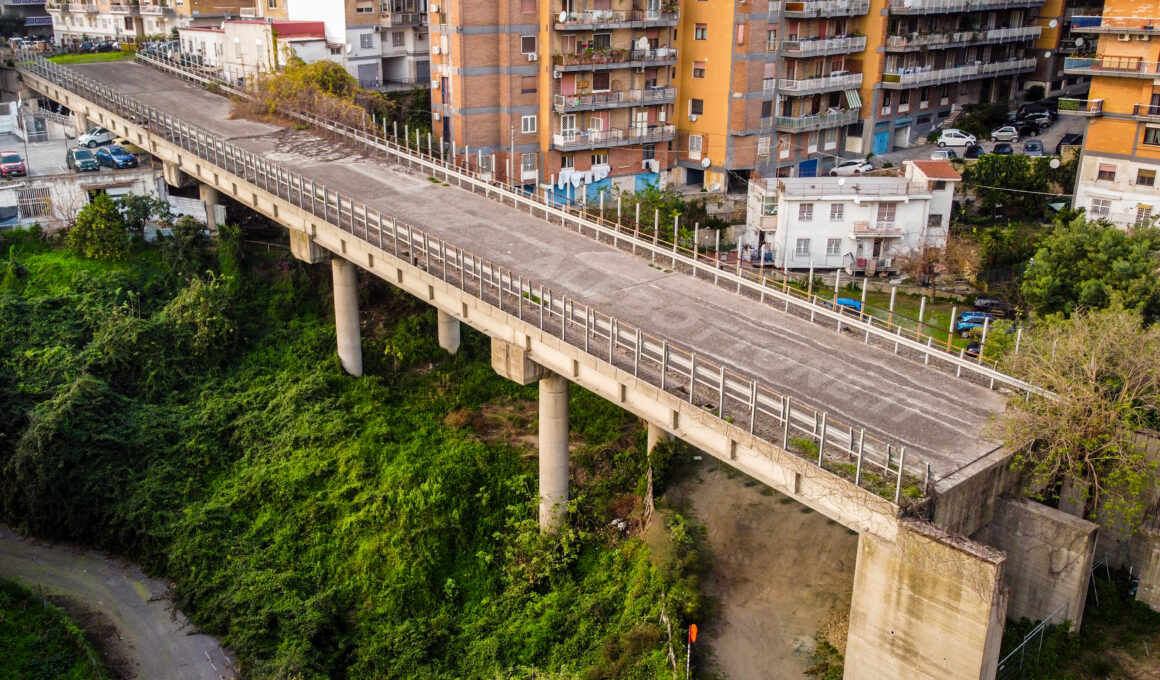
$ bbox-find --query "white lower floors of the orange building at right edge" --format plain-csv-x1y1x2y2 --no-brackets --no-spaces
1073,152,1160,229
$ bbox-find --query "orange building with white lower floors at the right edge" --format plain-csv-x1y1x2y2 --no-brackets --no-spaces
1059,0,1160,227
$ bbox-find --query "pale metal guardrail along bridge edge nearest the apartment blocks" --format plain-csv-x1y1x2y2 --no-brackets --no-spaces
127,53,1050,396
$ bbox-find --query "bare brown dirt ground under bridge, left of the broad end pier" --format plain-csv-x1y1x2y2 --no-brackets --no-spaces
666,456,858,680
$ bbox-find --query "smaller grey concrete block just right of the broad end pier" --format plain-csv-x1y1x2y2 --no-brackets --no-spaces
972,498,1099,629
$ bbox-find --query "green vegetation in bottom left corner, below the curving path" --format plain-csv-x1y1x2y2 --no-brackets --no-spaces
0,570,108,680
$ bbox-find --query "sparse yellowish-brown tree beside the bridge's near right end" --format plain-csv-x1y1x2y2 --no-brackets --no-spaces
995,309,1160,529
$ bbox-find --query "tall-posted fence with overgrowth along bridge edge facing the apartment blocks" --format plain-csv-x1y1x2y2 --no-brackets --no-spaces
127,55,1050,396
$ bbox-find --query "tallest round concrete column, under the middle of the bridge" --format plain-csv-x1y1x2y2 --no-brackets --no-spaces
539,372,568,534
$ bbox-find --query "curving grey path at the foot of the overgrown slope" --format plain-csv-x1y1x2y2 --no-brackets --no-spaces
0,527,237,680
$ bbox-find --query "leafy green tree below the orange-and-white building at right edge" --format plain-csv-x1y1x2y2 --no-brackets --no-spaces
1022,216,1160,323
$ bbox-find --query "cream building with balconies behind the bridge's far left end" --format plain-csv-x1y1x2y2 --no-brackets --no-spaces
45,0,254,45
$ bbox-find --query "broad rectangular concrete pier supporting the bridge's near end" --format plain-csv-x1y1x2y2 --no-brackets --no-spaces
843,520,1007,680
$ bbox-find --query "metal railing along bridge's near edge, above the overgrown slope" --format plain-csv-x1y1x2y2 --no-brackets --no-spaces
20,52,930,504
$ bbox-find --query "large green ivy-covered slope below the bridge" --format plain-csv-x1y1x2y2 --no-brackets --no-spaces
0,227,701,680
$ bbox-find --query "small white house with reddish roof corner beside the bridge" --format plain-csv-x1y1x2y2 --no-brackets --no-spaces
742,160,962,274
